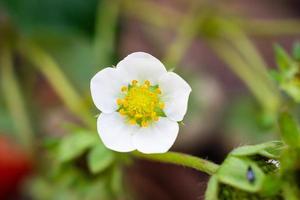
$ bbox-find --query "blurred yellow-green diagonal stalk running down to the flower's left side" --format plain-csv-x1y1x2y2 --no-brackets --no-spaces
20,44,95,129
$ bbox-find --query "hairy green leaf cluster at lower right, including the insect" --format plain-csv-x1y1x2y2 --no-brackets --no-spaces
205,141,285,200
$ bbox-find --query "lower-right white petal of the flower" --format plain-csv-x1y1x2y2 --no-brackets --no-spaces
133,117,179,153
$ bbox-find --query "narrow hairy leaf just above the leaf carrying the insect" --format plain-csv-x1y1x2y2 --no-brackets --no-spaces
230,141,284,158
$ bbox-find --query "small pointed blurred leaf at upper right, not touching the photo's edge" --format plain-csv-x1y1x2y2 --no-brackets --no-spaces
274,44,293,71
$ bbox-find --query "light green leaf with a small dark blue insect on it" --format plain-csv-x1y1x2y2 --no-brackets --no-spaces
216,156,265,192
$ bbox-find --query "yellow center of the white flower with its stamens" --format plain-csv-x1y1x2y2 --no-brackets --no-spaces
117,80,166,127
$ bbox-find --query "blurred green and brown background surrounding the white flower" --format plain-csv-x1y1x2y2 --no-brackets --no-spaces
0,0,300,200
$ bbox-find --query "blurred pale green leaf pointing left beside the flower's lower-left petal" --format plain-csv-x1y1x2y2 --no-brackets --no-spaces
58,130,99,162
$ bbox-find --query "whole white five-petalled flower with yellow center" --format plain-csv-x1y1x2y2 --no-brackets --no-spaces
91,52,191,153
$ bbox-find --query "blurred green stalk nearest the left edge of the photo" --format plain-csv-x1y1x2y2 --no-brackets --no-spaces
0,47,34,150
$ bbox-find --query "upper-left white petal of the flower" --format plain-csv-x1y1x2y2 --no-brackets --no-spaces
90,67,127,113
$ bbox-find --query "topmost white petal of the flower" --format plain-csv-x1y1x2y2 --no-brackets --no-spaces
117,52,167,84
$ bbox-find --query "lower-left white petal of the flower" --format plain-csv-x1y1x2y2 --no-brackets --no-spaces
97,112,137,152
